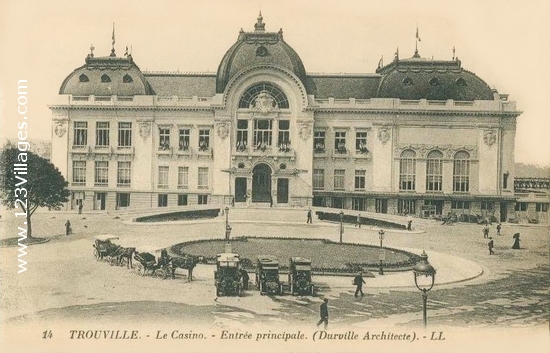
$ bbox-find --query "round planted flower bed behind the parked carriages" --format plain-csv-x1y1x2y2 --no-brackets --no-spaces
170,237,420,275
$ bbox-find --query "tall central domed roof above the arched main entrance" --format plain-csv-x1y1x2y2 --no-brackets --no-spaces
216,12,306,93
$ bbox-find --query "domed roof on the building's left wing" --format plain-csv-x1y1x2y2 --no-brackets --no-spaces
59,54,154,96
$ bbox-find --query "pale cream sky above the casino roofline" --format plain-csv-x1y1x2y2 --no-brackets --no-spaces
0,0,550,165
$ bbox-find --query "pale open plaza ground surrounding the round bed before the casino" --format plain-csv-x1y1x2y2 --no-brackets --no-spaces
0,208,549,348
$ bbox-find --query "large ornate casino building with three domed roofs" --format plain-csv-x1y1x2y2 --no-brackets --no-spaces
50,14,521,221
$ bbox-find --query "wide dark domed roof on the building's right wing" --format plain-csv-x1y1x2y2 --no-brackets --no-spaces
376,52,495,101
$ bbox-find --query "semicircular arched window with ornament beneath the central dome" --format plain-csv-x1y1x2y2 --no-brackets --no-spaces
239,82,288,109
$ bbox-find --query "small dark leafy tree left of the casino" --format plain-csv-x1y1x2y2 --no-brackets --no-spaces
0,143,70,238
